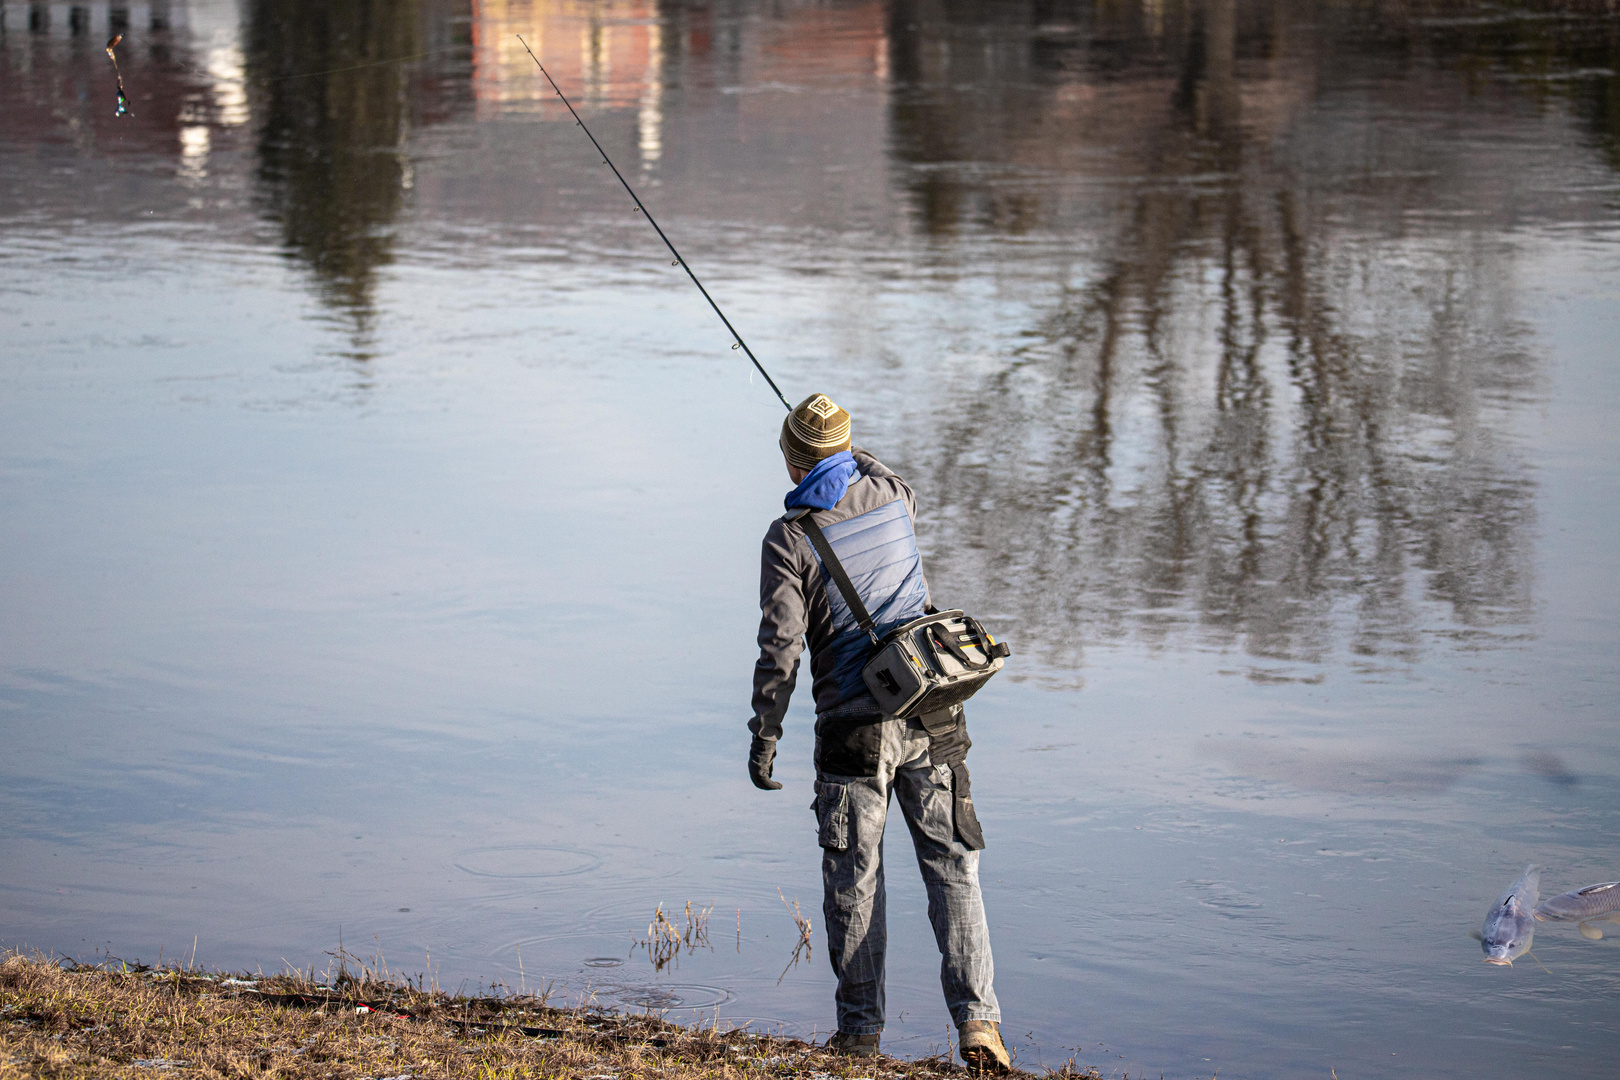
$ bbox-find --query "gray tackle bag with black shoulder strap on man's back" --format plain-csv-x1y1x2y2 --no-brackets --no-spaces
799,512,1013,721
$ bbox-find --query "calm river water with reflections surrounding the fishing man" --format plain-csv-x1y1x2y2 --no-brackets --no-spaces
0,0,1620,1077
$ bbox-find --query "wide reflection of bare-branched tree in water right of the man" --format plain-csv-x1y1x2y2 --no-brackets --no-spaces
891,0,1555,662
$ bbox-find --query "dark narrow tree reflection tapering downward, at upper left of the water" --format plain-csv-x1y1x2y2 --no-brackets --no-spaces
248,0,420,329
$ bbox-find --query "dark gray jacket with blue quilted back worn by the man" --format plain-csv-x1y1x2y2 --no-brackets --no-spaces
748,447,928,740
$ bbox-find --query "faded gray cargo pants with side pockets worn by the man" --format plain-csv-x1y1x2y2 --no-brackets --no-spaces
813,706,1001,1035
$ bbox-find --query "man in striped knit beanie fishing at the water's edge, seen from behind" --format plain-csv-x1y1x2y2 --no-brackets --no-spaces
748,393,1009,1072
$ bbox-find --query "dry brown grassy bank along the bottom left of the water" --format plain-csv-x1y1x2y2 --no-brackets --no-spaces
0,954,1097,1080
